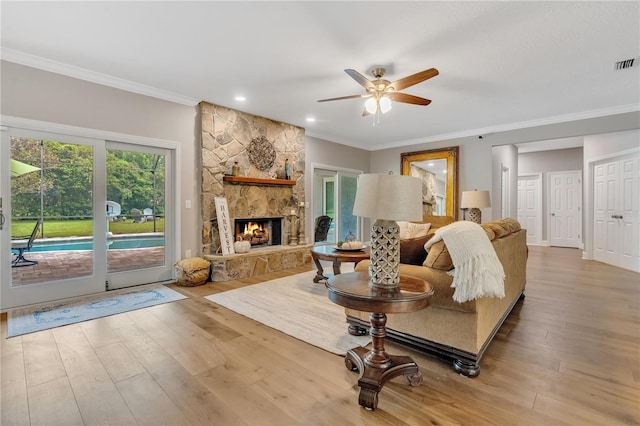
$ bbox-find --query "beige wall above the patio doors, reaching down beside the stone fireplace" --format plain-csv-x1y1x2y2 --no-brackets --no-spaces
0,61,200,255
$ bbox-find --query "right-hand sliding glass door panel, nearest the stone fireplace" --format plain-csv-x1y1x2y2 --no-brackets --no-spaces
105,142,174,290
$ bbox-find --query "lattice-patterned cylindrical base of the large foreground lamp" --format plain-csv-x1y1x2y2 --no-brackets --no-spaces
369,219,400,288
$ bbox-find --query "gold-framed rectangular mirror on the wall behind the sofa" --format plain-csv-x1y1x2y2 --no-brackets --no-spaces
400,146,458,220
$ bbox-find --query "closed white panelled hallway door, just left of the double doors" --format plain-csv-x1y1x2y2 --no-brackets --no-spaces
547,171,582,248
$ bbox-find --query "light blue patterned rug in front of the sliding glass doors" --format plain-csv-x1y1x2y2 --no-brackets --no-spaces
7,285,186,337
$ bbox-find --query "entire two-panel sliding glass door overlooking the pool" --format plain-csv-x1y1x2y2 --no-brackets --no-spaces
0,128,174,308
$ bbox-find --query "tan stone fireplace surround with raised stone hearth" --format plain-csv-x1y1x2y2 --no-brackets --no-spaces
199,102,312,281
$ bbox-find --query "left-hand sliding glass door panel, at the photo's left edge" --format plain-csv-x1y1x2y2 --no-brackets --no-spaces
0,129,106,308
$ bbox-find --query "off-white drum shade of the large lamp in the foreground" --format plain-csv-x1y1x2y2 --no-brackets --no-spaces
353,174,422,221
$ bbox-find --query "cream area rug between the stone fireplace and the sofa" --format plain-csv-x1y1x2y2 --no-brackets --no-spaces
206,271,371,355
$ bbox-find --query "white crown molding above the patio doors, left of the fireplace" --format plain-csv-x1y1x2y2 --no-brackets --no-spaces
0,48,200,106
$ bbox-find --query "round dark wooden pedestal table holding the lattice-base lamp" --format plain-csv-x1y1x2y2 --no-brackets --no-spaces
326,272,433,410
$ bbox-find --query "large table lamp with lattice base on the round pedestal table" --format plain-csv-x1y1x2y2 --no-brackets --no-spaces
353,174,422,288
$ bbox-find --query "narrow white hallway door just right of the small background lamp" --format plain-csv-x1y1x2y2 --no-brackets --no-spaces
517,174,542,245
